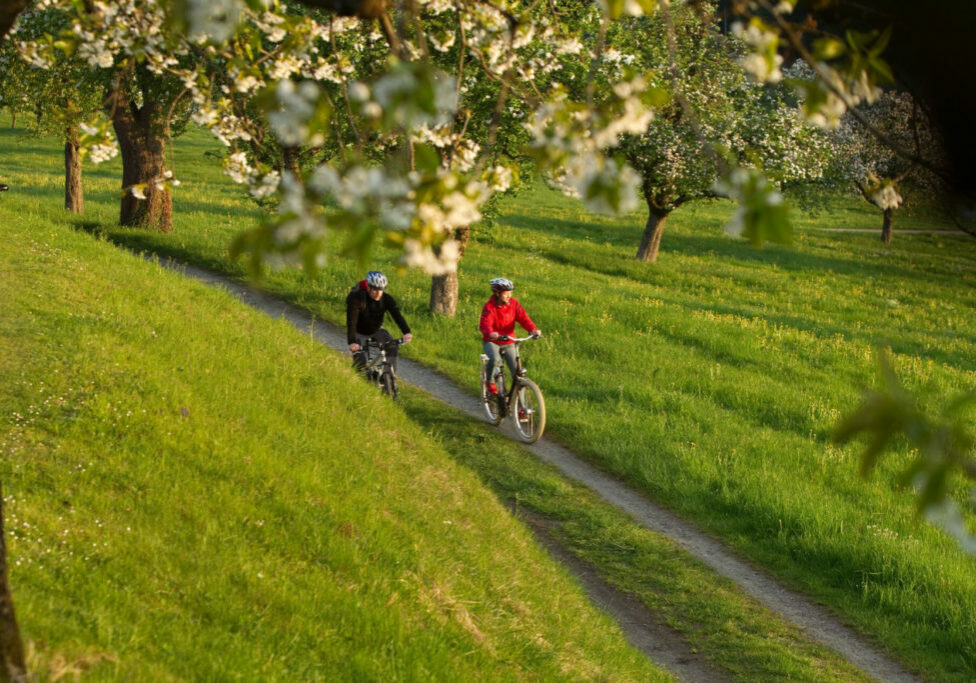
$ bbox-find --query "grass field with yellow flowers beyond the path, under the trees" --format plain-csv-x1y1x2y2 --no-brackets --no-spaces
0,117,976,680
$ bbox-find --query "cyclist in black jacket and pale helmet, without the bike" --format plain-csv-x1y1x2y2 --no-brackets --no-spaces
346,270,413,370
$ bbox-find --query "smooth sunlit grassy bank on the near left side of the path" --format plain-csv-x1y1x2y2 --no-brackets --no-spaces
0,136,661,680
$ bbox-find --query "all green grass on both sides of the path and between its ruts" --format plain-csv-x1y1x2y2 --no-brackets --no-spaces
0,120,976,681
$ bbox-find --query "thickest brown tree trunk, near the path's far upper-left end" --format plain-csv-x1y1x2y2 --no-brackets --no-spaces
111,93,173,232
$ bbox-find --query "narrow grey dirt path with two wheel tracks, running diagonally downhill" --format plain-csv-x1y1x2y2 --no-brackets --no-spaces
160,259,921,683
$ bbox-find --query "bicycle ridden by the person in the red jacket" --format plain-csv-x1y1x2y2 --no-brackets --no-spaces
481,337,546,443
